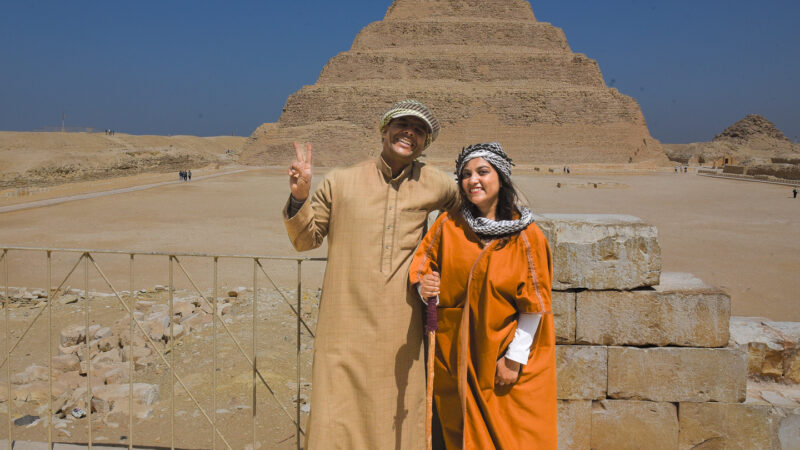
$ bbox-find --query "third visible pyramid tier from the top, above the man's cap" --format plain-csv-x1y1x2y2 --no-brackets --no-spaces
318,52,605,88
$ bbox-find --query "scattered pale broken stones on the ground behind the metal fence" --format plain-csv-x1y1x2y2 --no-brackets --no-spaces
0,285,239,437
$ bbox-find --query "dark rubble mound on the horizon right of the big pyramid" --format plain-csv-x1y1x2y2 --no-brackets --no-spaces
663,114,800,166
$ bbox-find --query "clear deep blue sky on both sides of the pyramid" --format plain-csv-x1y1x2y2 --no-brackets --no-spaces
0,0,800,143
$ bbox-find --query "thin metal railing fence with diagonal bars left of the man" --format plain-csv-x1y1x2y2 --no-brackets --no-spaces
0,246,325,449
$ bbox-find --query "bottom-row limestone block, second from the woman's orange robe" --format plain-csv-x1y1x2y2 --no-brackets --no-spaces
591,400,680,450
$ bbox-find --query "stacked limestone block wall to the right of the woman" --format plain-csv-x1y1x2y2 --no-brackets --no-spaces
537,214,800,449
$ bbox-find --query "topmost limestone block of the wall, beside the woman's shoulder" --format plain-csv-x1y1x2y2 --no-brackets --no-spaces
536,214,661,289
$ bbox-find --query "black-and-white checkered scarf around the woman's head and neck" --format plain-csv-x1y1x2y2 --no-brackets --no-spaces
456,142,533,238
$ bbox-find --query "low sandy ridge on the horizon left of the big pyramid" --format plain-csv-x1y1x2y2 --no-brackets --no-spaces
0,131,246,189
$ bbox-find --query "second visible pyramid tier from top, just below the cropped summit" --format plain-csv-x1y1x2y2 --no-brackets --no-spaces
351,20,570,52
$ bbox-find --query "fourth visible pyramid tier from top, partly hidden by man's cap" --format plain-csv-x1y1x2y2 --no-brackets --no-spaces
278,81,644,129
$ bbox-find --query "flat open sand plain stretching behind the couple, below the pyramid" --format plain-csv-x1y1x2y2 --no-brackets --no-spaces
0,168,800,321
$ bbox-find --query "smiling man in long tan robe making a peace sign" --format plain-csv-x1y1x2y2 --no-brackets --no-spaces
284,100,458,450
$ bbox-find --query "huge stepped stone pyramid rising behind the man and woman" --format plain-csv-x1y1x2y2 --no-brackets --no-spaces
240,0,668,166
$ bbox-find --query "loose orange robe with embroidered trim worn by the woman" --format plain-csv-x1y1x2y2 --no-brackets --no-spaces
409,212,557,450
